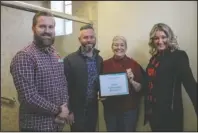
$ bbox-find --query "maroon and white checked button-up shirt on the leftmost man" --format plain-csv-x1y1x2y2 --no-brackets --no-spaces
10,42,68,131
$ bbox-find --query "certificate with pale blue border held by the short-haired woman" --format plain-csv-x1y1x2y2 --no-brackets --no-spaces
99,73,129,97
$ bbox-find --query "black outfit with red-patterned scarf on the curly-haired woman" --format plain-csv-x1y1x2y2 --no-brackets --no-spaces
145,50,197,132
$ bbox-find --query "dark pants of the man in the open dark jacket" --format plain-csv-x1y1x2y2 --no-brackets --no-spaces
71,101,98,132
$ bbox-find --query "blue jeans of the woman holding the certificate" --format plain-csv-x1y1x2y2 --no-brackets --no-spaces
104,109,137,132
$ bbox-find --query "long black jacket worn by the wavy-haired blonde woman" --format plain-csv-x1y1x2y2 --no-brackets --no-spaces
145,50,197,131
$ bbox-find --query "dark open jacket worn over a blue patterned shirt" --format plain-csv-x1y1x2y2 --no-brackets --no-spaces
64,48,103,112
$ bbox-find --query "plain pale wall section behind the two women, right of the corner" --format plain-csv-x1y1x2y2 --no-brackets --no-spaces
98,1,197,131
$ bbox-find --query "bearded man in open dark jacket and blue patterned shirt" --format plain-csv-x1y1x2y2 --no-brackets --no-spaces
64,25,103,132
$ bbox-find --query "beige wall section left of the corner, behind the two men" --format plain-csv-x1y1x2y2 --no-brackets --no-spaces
1,1,97,131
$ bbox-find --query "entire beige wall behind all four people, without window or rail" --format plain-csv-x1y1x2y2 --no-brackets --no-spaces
1,1,197,131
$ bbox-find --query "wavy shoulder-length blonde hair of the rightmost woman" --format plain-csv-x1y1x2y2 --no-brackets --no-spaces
148,23,179,55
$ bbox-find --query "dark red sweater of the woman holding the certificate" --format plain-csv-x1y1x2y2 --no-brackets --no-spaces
103,56,143,111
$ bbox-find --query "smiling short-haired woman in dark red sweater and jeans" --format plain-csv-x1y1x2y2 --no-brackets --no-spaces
102,36,143,132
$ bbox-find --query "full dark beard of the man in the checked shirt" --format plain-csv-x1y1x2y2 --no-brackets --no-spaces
34,33,55,48
